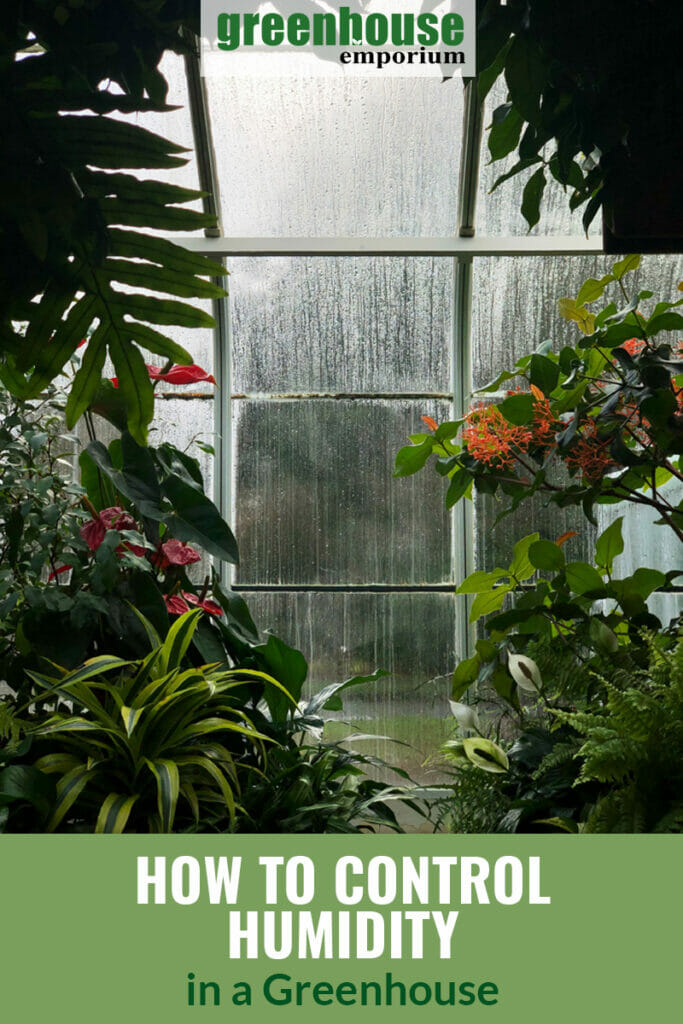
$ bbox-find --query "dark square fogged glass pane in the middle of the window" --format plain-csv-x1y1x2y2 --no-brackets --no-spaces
234,398,451,585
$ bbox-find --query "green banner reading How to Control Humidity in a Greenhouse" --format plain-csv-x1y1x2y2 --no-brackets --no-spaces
0,836,682,1024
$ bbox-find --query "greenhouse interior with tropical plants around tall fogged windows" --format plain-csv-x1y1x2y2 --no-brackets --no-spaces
0,0,683,835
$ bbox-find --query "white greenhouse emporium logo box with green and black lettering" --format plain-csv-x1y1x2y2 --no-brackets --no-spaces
202,0,476,79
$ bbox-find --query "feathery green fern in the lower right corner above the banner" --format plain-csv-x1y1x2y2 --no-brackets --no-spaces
555,632,683,833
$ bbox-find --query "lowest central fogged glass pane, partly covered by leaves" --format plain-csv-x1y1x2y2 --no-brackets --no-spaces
240,592,460,782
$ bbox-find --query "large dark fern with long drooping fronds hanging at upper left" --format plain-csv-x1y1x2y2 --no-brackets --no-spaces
0,0,224,444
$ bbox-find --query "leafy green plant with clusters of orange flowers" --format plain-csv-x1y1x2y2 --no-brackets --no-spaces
395,256,683,540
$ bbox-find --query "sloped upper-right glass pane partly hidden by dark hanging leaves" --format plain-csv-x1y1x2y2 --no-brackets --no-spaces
476,80,602,238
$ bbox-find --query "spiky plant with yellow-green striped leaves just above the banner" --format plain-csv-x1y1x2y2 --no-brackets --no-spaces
2,609,291,833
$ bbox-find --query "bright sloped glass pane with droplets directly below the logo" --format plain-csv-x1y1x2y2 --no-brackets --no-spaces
209,77,463,238
